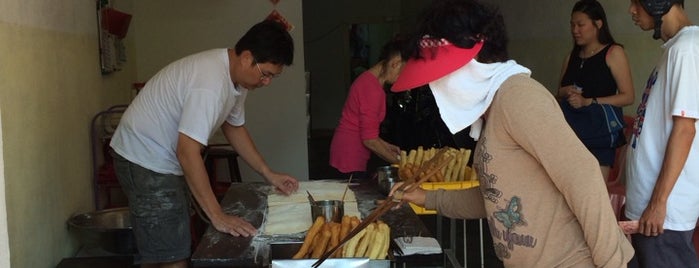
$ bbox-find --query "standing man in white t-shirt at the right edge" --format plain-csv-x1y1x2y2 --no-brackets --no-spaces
626,0,699,267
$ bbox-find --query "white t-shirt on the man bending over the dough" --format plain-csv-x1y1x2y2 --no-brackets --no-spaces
110,48,248,175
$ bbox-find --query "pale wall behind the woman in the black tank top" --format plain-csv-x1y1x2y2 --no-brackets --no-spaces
488,0,699,115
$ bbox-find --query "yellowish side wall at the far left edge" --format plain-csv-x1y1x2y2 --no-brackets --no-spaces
0,0,135,268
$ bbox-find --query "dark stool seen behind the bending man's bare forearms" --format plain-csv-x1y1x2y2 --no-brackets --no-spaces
203,144,242,200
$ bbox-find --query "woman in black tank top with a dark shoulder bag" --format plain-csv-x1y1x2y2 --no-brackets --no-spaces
557,0,634,180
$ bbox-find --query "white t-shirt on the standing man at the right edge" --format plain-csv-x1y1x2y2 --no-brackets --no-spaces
626,26,699,231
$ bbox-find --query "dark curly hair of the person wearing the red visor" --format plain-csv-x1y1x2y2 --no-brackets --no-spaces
407,0,509,63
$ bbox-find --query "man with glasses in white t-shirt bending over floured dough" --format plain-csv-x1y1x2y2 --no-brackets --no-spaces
110,21,298,267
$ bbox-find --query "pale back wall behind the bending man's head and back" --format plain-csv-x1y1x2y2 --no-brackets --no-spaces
130,0,308,181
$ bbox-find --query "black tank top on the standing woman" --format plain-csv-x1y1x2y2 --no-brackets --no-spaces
560,45,617,98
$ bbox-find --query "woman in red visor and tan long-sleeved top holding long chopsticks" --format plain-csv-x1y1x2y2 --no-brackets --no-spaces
392,0,634,267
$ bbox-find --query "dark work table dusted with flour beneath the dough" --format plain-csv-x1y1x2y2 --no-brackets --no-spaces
191,182,444,267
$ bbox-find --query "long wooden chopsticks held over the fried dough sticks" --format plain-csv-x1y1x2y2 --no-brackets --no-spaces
311,148,452,268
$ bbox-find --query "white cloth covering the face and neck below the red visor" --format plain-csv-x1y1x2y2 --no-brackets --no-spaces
429,59,531,140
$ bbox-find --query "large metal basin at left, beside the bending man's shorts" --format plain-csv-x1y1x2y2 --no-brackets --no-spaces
68,207,137,255
